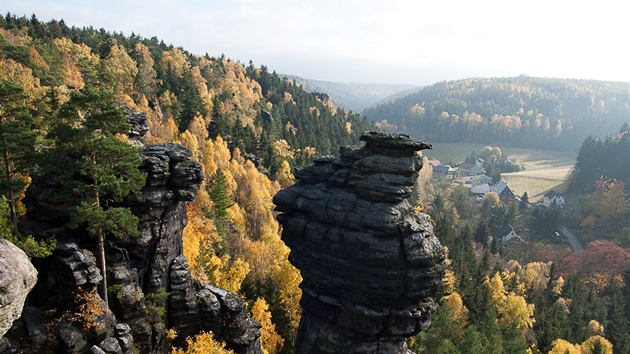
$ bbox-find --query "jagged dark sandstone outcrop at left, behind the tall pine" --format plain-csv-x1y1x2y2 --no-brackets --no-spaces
10,114,262,354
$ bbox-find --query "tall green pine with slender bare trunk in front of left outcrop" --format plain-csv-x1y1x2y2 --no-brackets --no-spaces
51,86,146,304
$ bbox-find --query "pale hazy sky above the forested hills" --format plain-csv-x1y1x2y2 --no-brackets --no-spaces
0,0,630,86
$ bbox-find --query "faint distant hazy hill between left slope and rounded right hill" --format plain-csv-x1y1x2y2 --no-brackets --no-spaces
282,75,414,112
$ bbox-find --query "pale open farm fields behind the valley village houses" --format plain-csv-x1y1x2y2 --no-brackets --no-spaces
423,143,577,202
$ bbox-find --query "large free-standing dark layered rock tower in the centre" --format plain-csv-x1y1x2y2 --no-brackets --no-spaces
274,133,446,354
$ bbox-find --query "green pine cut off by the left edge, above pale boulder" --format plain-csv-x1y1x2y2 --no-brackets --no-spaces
0,80,35,236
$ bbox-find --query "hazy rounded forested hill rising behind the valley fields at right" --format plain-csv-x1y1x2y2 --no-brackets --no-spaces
363,76,630,150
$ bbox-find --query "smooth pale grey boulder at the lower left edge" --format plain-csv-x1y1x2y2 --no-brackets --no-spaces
0,237,37,338
